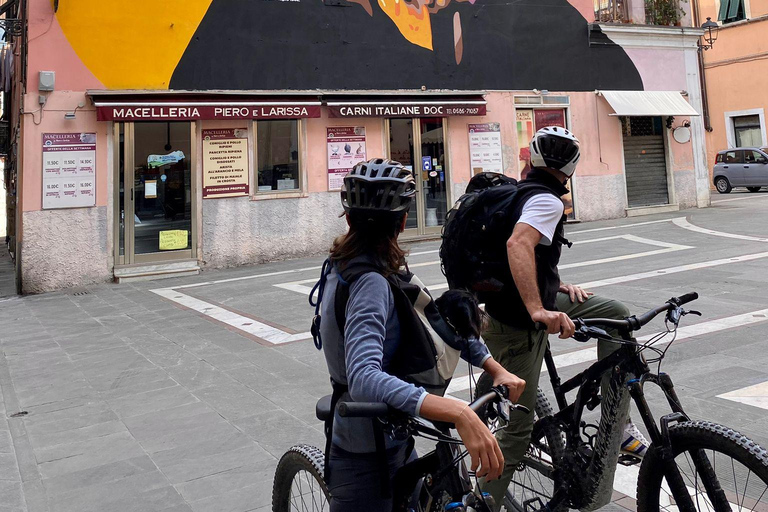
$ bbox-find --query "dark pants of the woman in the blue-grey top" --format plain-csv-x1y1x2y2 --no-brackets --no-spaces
328,443,416,512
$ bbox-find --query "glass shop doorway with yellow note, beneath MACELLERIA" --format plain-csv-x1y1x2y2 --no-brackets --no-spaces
114,121,197,265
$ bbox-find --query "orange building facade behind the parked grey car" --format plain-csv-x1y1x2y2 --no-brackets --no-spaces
699,0,768,178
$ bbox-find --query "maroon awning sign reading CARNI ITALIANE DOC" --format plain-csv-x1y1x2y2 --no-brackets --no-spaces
328,102,486,117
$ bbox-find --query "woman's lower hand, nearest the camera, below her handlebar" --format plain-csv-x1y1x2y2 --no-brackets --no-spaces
454,406,504,480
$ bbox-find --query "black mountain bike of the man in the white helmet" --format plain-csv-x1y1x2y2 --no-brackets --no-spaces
477,293,768,512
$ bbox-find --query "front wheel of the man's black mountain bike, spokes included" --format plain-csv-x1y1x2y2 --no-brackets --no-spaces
637,421,768,512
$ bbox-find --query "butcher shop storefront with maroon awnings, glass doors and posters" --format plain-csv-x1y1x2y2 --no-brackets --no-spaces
89,91,492,281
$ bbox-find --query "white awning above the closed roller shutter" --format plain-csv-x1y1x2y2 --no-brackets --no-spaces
598,91,699,116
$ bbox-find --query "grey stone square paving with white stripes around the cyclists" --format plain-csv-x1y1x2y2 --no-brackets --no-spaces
0,193,768,512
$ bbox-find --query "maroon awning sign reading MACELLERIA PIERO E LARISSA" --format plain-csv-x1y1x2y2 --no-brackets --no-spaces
96,103,320,121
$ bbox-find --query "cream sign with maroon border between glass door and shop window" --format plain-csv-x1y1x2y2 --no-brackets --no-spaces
202,128,250,199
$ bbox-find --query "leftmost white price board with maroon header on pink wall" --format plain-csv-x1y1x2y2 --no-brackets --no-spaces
43,133,96,209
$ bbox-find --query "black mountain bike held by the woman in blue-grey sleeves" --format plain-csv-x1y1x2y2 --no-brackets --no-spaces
272,387,530,512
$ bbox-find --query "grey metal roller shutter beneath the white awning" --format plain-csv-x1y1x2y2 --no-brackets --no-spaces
624,118,669,208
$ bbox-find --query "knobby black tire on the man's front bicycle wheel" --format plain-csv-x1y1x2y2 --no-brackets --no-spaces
637,421,768,512
